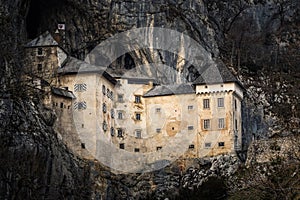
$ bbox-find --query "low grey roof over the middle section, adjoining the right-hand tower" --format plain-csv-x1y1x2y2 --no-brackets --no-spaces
143,83,195,97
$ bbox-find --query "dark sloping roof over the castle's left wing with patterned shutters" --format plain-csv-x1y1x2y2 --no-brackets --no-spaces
57,56,117,84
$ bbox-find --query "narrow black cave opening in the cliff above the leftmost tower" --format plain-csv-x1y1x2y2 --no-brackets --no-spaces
26,0,42,39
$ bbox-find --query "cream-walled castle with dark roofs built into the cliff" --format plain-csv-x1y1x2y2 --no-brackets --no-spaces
26,32,244,168
